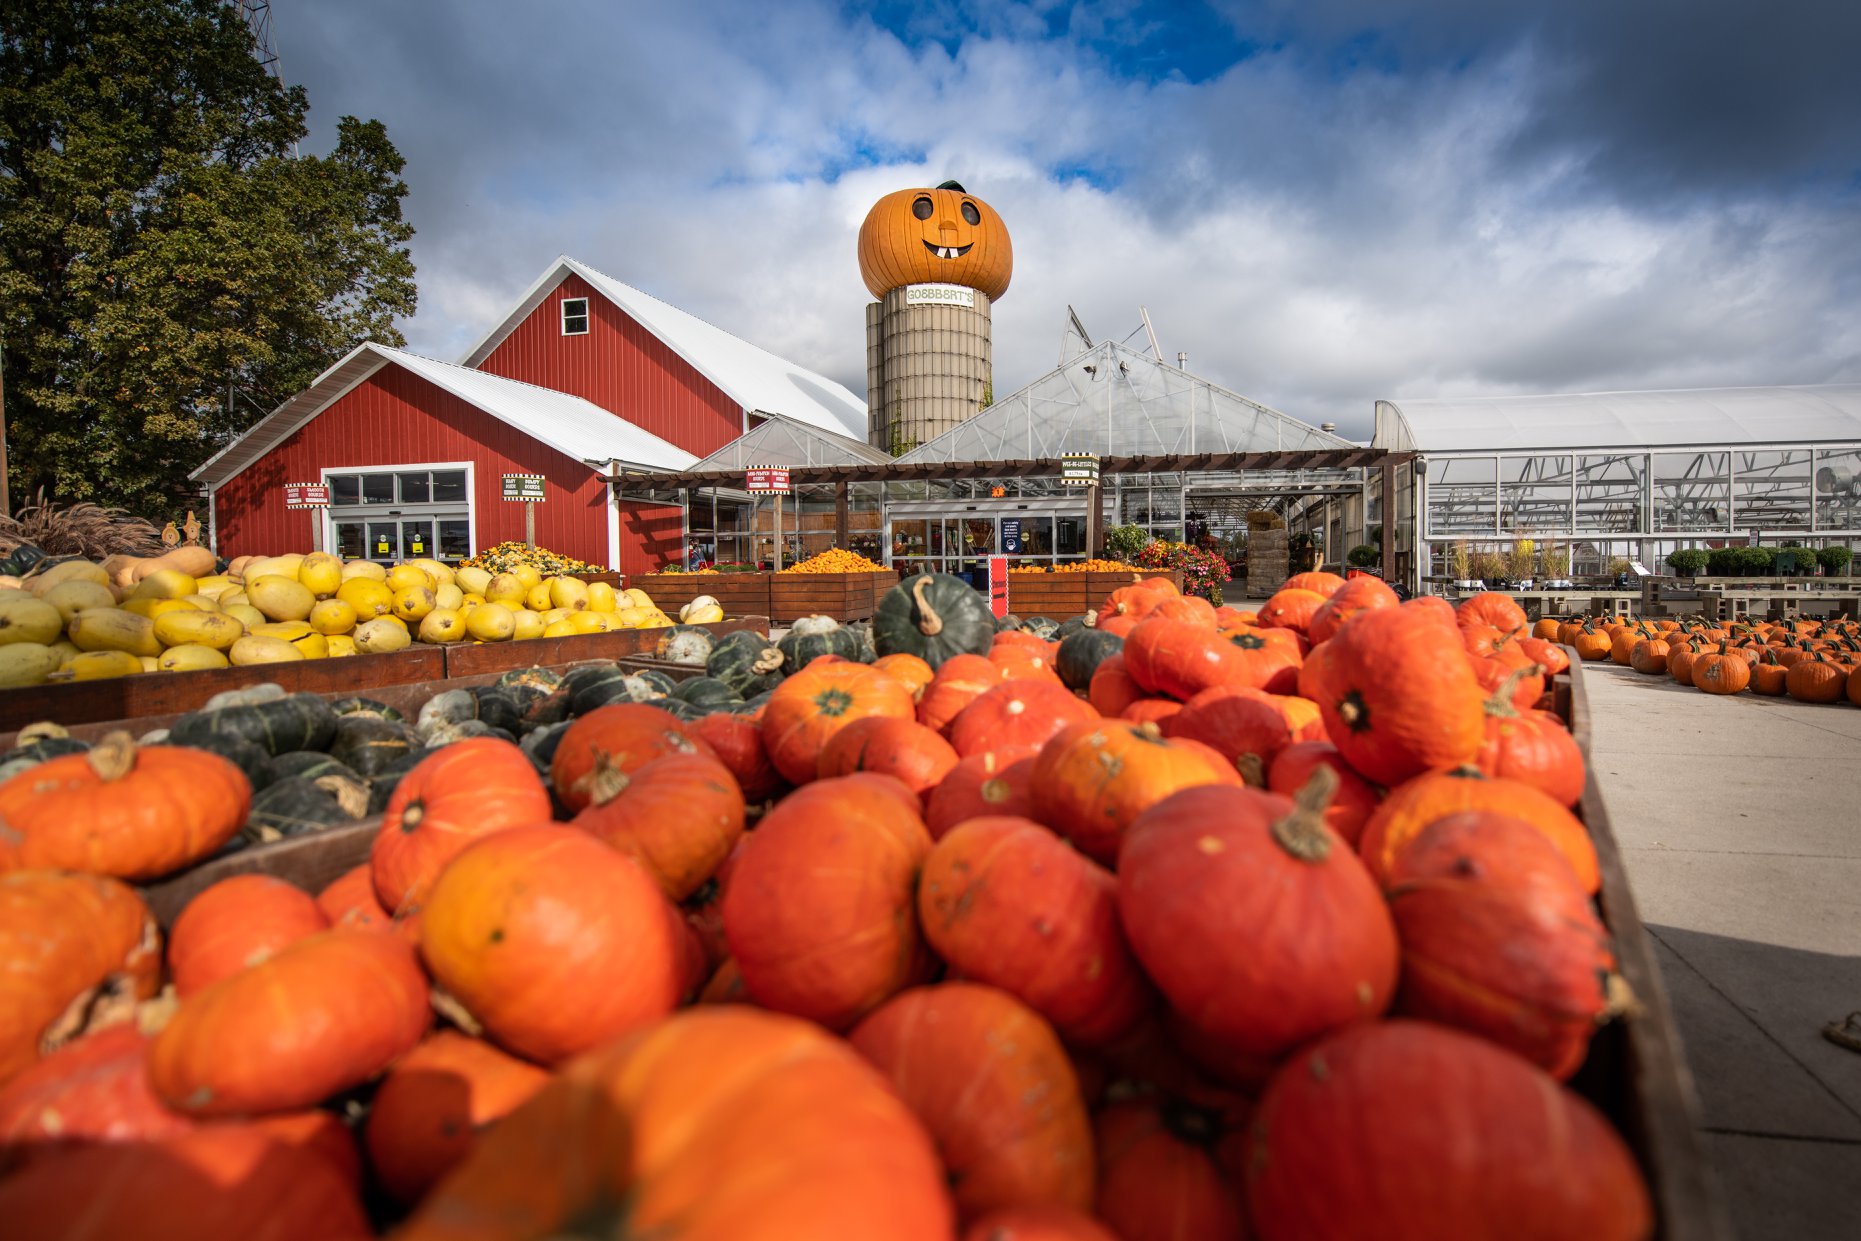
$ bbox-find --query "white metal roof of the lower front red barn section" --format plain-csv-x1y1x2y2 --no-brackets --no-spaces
190,342,698,487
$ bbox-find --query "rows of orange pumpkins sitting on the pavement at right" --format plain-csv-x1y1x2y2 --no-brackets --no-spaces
1532,618,1861,707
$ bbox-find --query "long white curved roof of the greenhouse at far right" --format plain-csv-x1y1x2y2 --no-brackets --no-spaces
1372,383,1861,452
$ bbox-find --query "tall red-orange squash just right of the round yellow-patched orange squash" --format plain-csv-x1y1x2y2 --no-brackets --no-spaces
724,772,931,1029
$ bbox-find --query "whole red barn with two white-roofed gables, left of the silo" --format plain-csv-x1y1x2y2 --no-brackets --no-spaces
194,257,865,573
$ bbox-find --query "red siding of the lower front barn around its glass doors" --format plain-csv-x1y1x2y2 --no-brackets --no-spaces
214,365,681,573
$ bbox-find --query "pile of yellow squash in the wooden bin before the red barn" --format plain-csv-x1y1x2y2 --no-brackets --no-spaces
0,547,724,688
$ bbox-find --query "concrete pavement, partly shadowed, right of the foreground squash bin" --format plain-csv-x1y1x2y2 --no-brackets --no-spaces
1584,664,1861,1241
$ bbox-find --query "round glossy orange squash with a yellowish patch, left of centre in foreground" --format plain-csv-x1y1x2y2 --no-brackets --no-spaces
421,826,685,1064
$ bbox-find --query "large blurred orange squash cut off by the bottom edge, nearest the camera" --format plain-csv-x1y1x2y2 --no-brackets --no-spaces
396,1005,955,1241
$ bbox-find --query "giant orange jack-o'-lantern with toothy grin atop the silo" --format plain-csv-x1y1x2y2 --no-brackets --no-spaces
860,180,1014,301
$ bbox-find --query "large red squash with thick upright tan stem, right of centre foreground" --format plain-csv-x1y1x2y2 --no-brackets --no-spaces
1118,767,1398,1057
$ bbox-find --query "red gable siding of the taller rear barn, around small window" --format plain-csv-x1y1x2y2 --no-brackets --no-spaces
478,272,743,456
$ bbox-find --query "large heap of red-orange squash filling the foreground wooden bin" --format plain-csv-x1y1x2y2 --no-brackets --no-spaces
0,575,1653,1241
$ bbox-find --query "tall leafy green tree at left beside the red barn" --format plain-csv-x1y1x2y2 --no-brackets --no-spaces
0,0,415,514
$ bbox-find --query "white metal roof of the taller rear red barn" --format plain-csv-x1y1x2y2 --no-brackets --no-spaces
462,255,865,439
